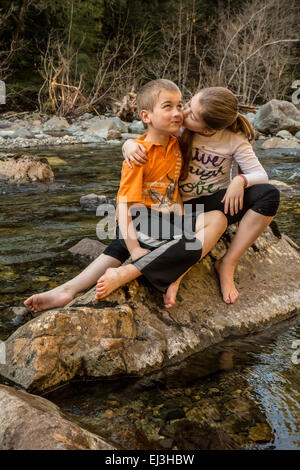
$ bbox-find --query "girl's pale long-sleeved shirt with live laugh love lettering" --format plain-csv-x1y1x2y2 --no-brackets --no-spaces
179,129,268,201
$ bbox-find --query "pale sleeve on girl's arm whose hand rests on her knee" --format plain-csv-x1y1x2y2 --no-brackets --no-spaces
231,132,268,187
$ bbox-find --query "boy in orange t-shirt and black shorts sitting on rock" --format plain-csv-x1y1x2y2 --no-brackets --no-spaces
96,79,202,299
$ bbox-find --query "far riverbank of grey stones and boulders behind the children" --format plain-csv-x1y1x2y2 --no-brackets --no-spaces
0,100,300,149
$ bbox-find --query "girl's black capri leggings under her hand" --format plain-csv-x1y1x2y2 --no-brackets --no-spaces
184,184,280,225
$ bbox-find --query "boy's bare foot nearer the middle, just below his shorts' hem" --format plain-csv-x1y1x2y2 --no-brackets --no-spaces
95,264,141,300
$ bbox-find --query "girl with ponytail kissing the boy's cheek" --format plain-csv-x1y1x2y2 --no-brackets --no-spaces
123,87,280,304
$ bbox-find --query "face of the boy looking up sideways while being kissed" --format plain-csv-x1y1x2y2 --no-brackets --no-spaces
141,90,183,135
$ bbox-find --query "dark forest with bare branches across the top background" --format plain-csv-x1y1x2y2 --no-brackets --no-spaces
0,0,300,116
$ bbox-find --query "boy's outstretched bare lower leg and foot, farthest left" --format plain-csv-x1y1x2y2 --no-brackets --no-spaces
24,254,121,312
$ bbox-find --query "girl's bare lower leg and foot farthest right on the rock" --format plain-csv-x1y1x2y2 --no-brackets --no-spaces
215,209,273,304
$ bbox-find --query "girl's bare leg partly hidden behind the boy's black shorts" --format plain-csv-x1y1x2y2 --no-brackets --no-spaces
163,211,227,308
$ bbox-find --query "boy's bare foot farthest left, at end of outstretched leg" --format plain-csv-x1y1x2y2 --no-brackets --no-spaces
24,287,74,312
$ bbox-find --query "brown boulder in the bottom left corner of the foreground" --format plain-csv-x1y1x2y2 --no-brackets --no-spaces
0,385,118,450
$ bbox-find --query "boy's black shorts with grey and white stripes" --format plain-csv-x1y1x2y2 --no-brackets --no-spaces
103,207,202,293
